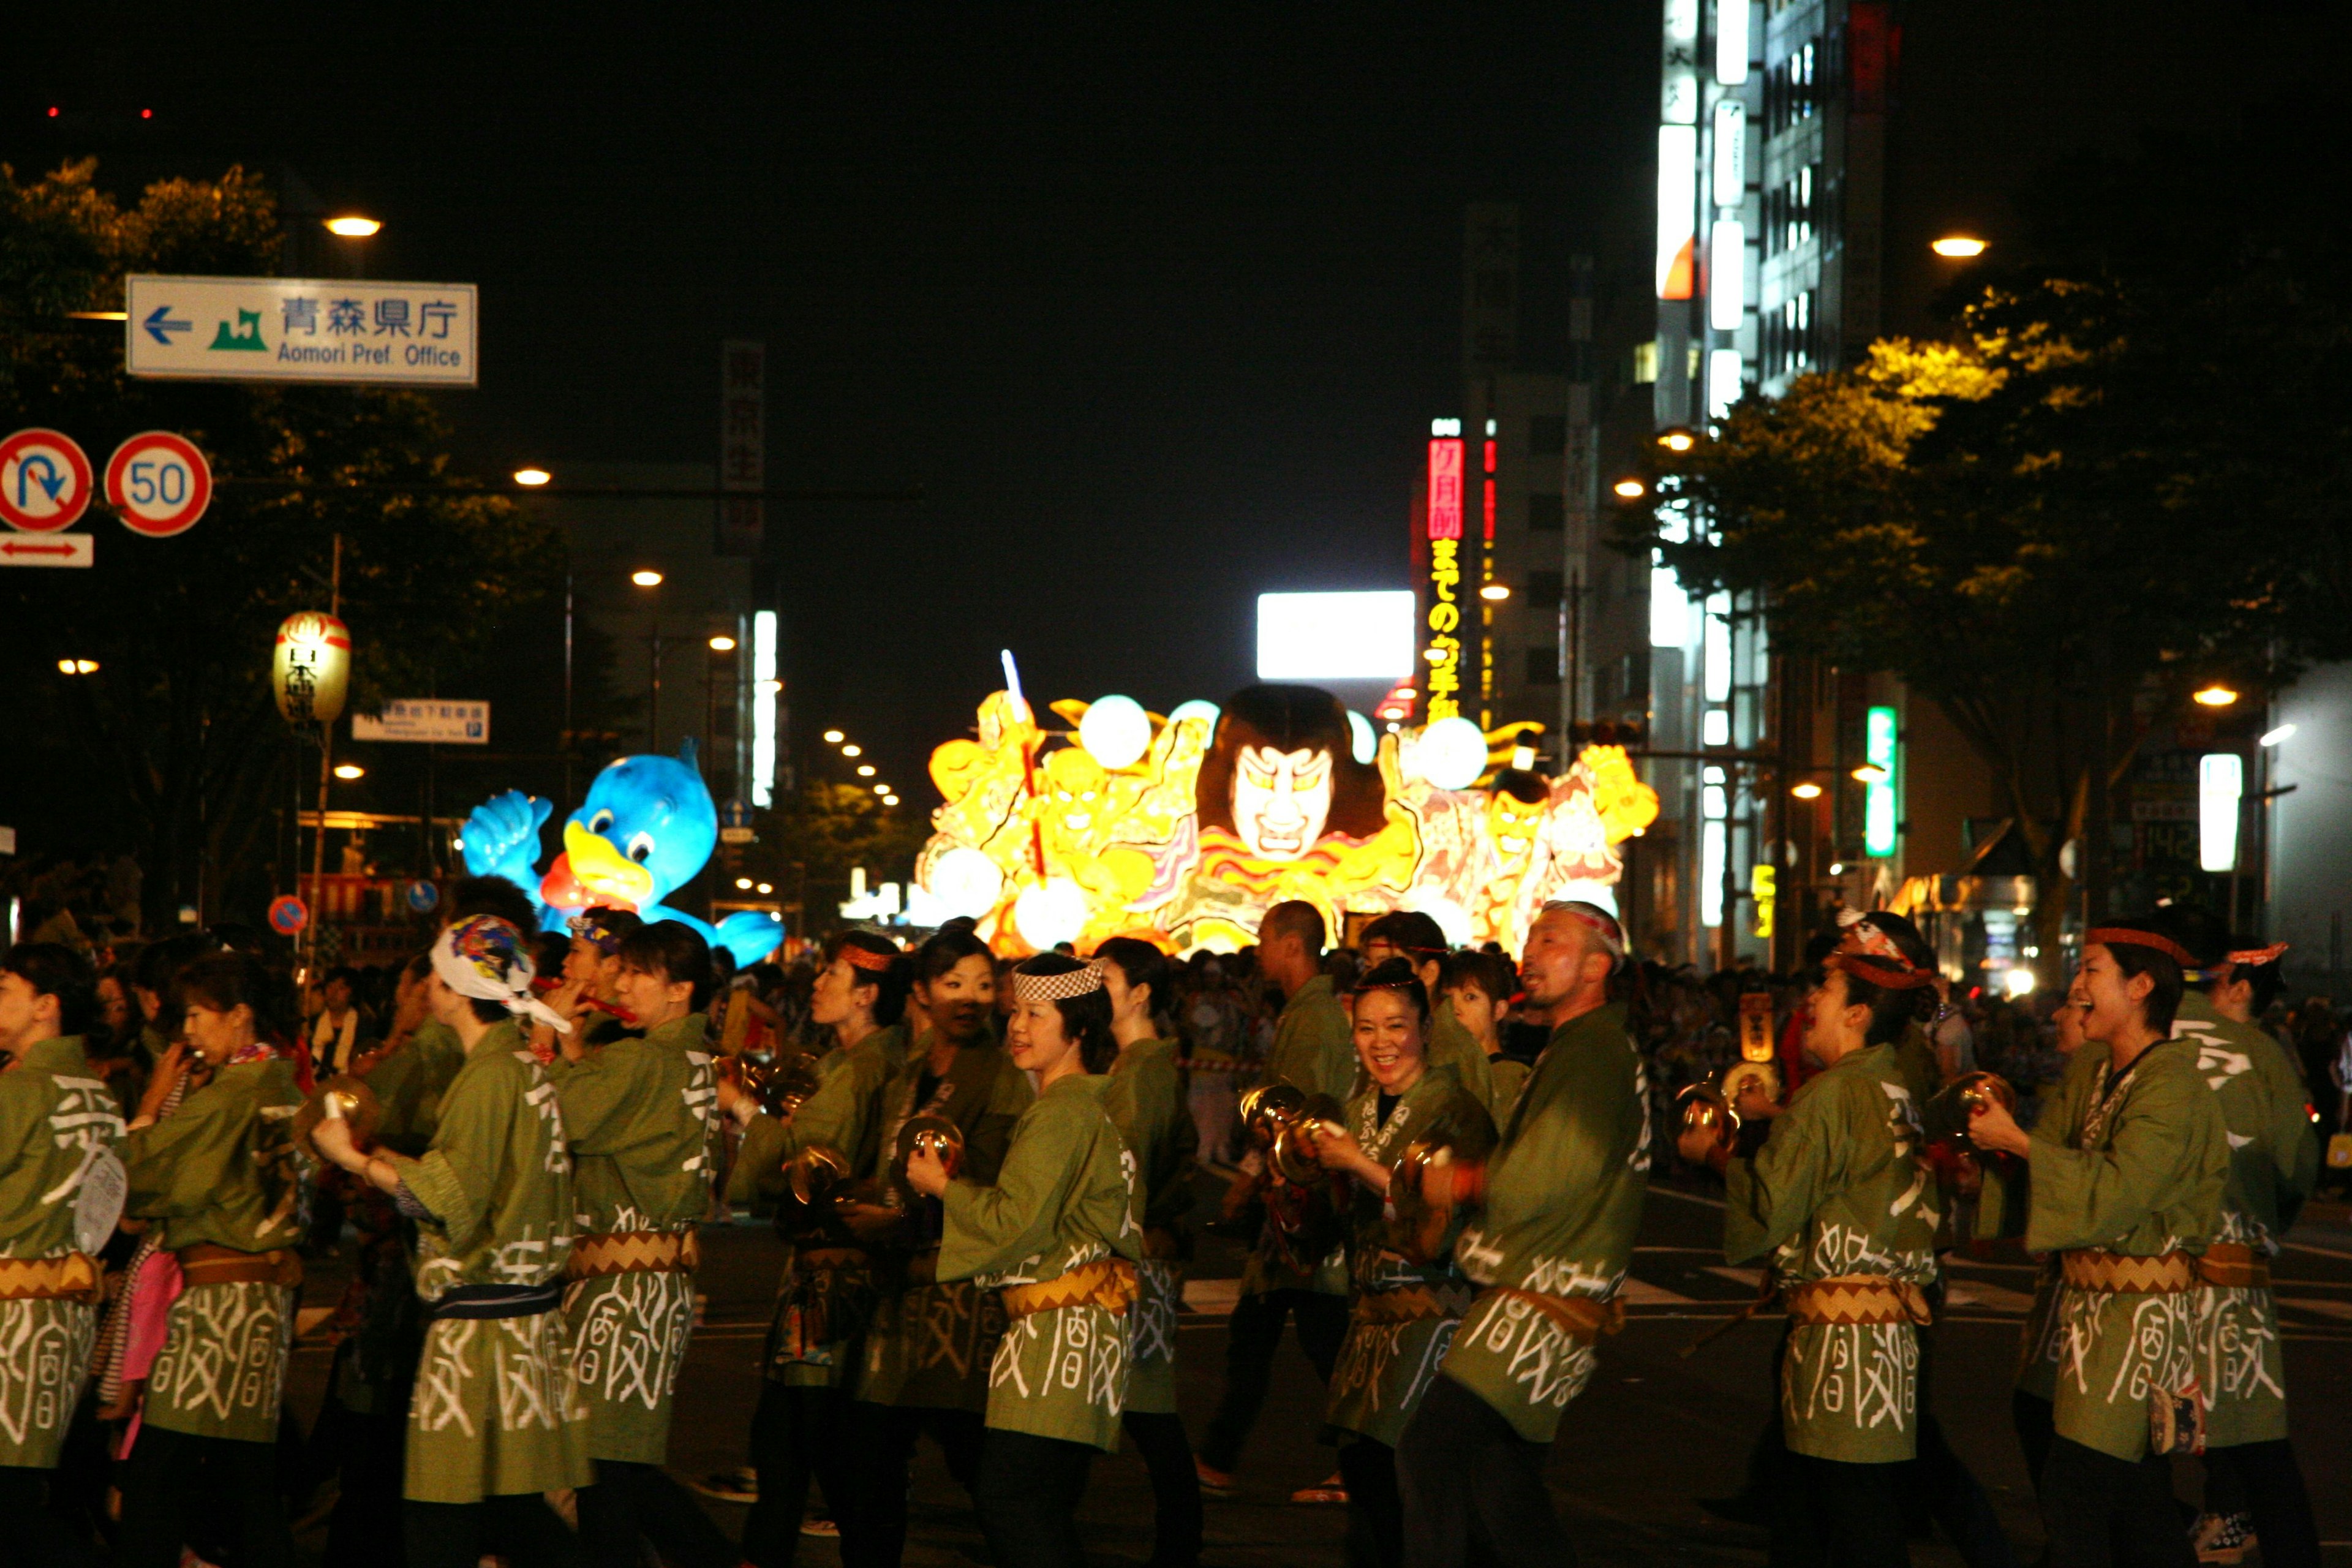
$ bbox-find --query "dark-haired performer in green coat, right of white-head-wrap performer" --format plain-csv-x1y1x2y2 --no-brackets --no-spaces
548,922,741,1568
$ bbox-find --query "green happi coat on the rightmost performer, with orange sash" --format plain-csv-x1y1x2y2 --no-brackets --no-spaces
2173,992,2319,1448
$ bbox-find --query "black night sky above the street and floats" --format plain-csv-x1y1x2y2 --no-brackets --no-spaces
0,0,1658,799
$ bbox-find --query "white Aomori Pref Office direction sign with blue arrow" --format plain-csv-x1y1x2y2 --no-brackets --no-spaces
123,273,478,385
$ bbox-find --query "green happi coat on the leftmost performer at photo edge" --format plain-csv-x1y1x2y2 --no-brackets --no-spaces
0,1035,123,1469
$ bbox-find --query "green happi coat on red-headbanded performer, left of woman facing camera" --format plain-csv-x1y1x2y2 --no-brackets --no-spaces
727,1025,905,1387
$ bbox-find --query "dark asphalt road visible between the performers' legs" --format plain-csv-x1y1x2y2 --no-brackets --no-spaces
296,1175,2352,1568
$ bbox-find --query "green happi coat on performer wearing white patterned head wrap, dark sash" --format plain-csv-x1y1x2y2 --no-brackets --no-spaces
388,1023,595,1502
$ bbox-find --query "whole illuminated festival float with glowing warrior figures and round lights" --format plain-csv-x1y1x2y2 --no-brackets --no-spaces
915,684,1658,952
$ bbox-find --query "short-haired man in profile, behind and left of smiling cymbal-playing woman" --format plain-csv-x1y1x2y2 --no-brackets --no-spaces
1195,900,1355,1502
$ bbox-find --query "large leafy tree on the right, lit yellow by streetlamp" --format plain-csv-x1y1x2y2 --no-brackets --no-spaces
1623,266,2347,954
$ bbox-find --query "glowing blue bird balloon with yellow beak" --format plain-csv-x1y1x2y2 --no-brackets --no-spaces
463,738,783,964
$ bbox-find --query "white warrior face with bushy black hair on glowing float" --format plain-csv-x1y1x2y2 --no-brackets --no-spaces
1195,687,1385,861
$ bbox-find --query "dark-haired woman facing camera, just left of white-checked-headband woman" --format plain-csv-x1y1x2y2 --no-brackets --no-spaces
846,929,1033,1568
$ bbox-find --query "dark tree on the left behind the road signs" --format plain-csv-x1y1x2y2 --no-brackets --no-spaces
0,162,560,926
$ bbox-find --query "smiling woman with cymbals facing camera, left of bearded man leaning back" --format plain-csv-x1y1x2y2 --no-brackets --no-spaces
1315,959,1493,1568
